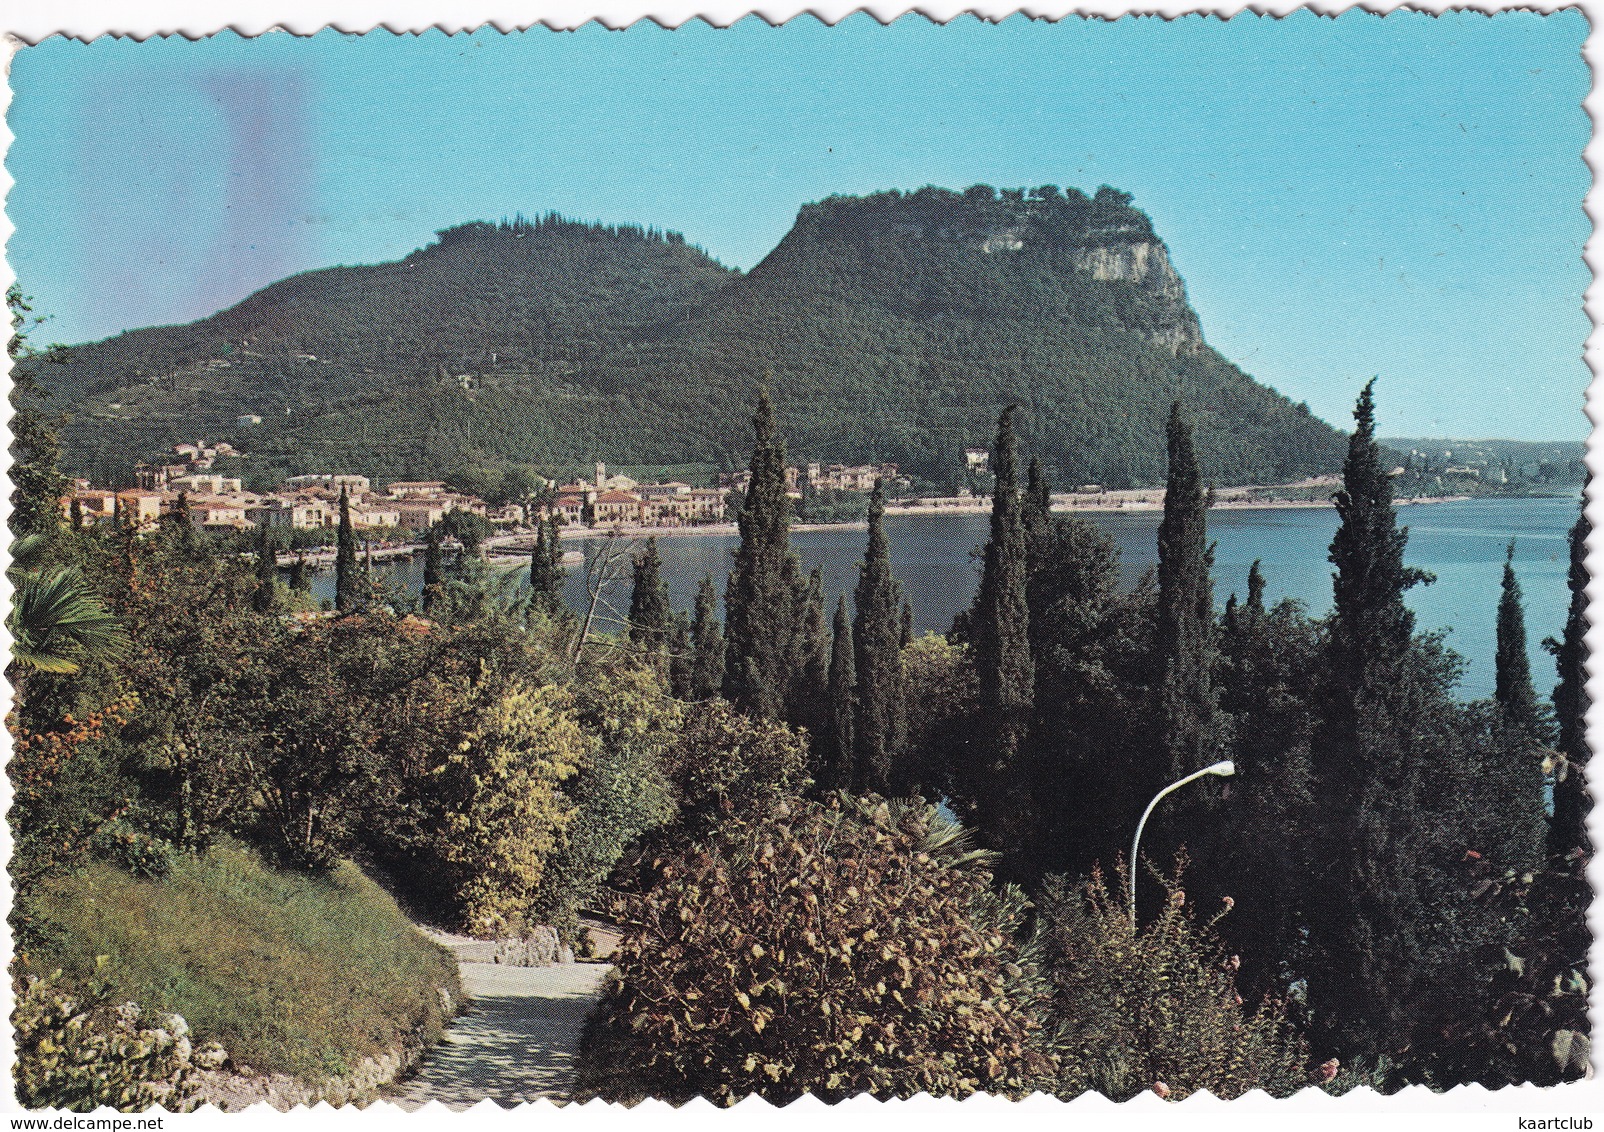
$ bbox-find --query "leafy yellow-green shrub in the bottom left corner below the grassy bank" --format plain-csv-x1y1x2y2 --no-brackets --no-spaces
11,956,226,1113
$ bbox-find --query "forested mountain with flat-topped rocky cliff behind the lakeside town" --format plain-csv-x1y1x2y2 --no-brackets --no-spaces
31,186,1341,486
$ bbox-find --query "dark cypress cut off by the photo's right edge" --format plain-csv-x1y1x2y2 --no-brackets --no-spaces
1543,497,1593,861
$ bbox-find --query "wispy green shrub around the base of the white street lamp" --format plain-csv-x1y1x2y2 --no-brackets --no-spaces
1041,869,1315,1100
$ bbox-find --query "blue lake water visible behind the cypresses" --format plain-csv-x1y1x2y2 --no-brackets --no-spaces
316,499,1577,699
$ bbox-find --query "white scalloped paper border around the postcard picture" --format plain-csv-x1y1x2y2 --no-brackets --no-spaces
0,0,1604,1115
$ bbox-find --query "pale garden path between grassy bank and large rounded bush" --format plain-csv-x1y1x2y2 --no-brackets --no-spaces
385,962,611,1110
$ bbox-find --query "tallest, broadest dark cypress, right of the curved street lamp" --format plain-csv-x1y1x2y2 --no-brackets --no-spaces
1306,382,1453,1061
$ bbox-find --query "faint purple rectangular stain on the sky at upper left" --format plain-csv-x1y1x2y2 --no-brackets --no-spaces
74,67,316,333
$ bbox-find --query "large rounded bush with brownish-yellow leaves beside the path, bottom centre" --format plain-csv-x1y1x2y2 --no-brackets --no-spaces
581,795,1054,1105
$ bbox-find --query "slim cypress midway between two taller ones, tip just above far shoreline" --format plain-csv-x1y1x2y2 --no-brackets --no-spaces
852,483,903,794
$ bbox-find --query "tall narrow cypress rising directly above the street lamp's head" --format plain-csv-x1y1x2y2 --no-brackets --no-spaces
1153,401,1216,785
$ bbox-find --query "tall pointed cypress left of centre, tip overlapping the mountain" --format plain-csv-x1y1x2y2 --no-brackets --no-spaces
723,388,799,720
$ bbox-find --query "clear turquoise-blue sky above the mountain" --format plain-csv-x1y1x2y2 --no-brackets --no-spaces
6,11,1590,439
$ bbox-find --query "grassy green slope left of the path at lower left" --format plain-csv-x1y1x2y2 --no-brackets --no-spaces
32,847,459,1079
